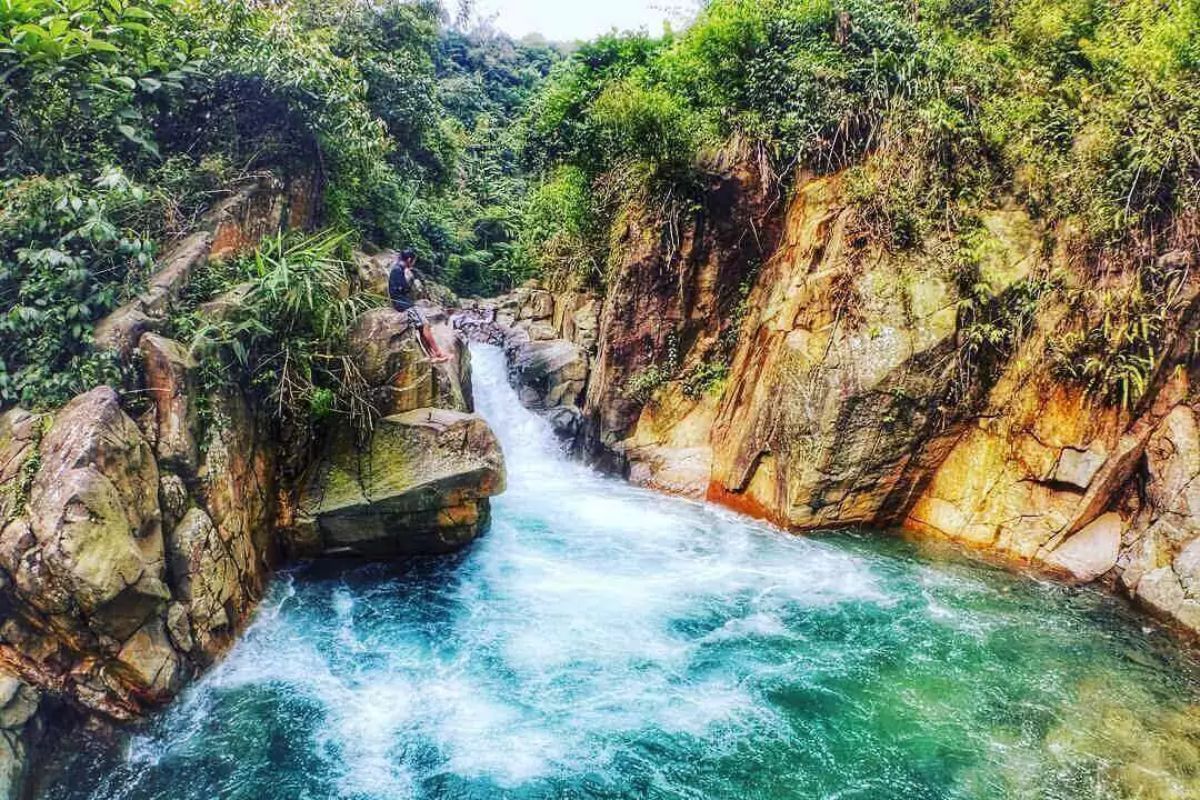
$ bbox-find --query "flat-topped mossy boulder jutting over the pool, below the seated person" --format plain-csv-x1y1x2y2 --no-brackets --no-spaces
302,409,505,557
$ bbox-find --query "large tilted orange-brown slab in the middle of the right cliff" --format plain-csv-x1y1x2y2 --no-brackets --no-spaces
713,176,1037,537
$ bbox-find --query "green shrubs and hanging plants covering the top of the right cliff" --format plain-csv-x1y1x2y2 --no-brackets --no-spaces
521,0,1200,403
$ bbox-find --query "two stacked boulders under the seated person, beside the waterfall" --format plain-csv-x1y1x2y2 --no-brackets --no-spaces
286,301,504,558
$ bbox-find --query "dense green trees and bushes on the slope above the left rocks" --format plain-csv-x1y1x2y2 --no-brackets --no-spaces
0,0,552,413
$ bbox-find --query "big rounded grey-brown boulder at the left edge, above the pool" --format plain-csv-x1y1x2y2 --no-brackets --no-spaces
0,386,182,717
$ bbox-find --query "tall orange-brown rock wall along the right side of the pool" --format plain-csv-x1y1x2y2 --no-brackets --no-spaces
482,168,1200,631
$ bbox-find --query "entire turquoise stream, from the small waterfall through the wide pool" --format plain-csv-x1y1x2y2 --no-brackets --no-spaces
38,348,1200,800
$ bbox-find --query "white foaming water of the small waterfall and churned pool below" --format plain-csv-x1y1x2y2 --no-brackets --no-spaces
103,347,889,799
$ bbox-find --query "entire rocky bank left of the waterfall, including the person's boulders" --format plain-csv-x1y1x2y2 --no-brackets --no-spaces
0,179,504,798
